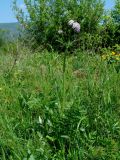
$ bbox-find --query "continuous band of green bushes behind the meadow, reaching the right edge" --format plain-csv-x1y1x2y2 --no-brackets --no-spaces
13,0,120,50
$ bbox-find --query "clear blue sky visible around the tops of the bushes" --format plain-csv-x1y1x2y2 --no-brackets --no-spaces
0,0,114,23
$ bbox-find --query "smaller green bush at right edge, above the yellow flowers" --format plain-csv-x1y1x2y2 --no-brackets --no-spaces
102,0,120,47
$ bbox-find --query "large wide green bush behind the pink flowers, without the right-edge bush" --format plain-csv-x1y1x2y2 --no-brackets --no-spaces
13,0,104,50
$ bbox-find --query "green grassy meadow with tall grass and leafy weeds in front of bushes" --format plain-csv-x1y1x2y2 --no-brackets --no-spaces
0,50,120,160
